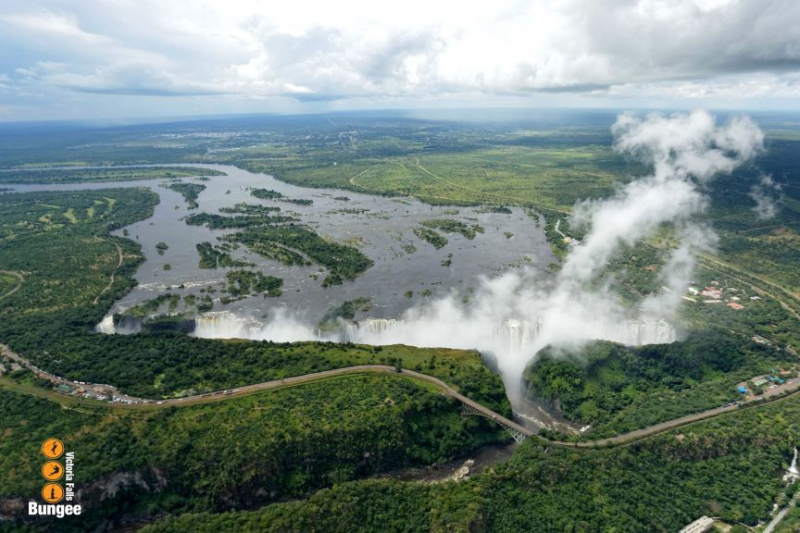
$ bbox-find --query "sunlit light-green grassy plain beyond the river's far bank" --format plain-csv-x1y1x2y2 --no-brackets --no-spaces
242,145,628,210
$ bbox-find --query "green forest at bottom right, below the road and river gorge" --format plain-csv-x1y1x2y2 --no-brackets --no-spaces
138,386,800,533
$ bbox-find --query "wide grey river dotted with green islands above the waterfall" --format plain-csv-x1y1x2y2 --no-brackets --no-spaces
1,165,554,323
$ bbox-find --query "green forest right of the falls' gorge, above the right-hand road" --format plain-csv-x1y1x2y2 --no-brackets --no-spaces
525,329,797,439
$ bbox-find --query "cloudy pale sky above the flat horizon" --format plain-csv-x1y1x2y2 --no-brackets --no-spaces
0,0,800,121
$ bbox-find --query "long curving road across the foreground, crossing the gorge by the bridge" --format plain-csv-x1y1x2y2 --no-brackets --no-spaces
0,344,800,448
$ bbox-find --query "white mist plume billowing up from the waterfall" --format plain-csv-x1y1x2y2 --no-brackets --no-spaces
186,111,764,395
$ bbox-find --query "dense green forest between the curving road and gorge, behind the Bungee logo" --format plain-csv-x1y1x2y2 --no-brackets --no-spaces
0,374,506,531
